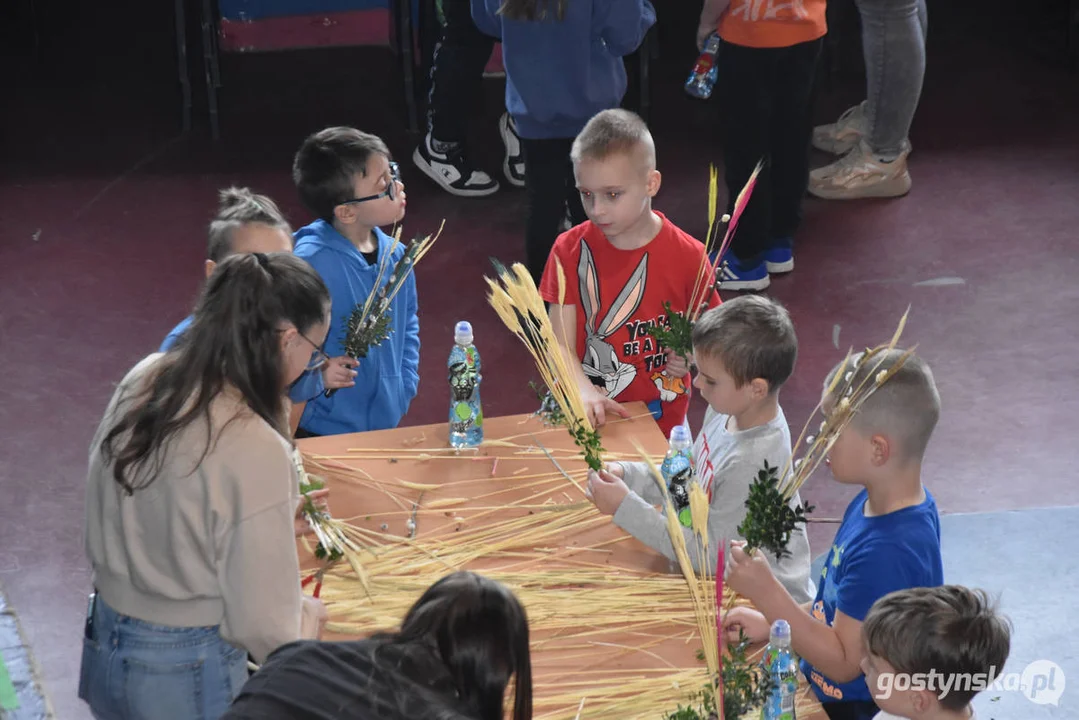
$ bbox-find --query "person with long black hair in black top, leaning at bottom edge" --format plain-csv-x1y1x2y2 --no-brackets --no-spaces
222,571,532,720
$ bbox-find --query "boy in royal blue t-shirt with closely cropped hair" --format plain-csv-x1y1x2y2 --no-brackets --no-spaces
724,350,944,720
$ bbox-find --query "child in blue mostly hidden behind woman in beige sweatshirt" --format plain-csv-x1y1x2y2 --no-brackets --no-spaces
159,188,356,416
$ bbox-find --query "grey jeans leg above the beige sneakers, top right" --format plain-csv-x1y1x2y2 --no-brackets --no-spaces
856,0,928,159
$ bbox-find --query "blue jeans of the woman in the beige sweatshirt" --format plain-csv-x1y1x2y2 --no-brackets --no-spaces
79,597,247,720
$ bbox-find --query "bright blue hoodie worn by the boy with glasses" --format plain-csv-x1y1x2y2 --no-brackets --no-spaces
293,220,420,435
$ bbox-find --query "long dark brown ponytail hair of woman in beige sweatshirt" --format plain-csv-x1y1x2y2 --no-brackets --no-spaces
101,253,330,494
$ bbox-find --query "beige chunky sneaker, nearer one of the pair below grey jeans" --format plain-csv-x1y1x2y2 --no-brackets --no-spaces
809,140,911,200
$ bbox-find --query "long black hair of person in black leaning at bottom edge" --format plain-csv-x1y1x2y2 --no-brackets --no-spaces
377,571,532,720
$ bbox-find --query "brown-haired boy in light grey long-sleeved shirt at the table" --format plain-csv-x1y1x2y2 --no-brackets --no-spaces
589,295,815,602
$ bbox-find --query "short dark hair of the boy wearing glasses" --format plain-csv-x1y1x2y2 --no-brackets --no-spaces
292,127,391,222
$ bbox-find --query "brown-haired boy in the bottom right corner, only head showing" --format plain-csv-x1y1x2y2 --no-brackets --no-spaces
862,585,1011,720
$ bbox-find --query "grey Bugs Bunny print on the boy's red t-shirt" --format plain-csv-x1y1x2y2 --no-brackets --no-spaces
577,240,648,398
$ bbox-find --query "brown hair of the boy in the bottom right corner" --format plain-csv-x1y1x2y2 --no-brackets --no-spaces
862,585,1011,710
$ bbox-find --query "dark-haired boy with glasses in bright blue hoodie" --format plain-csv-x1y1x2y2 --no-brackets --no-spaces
292,127,420,437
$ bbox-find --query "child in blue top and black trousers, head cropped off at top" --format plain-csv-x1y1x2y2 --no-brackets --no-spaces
472,0,656,284
